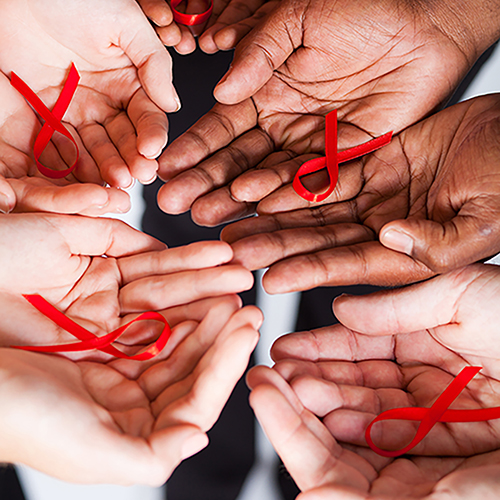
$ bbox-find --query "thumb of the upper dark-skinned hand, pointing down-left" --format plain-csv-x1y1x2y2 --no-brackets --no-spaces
214,0,302,104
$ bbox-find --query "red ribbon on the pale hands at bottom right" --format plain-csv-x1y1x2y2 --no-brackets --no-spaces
365,366,500,457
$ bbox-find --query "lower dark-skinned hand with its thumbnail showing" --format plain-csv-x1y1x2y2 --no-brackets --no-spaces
222,94,500,293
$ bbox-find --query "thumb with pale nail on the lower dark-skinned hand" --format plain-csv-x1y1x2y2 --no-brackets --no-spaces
379,215,500,273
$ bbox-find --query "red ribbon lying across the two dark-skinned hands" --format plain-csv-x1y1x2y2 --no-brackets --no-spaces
293,109,392,202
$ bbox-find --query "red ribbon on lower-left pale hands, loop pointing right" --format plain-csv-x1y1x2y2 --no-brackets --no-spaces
11,295,171,361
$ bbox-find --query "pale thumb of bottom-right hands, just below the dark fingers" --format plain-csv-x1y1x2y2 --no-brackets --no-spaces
334,267,484,335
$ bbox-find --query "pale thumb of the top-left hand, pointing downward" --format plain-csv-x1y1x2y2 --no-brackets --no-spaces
120,5,180,112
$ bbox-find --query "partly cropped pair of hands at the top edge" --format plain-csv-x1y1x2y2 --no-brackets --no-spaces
137,0,277,54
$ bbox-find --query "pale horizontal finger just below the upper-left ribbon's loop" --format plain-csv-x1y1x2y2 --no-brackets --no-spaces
9,179,130,216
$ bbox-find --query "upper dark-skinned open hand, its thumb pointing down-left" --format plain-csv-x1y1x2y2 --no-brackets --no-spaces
158,0,500,226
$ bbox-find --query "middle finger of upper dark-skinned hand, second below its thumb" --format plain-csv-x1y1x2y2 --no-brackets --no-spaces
158,129,273,214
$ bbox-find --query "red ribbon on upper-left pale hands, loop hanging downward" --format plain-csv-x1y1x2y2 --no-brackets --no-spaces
10,64,80,179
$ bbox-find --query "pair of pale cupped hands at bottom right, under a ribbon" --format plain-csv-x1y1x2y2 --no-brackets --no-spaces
248,265,500,500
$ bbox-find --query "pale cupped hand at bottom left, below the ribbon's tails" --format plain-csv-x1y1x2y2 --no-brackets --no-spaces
0,300,261,486
